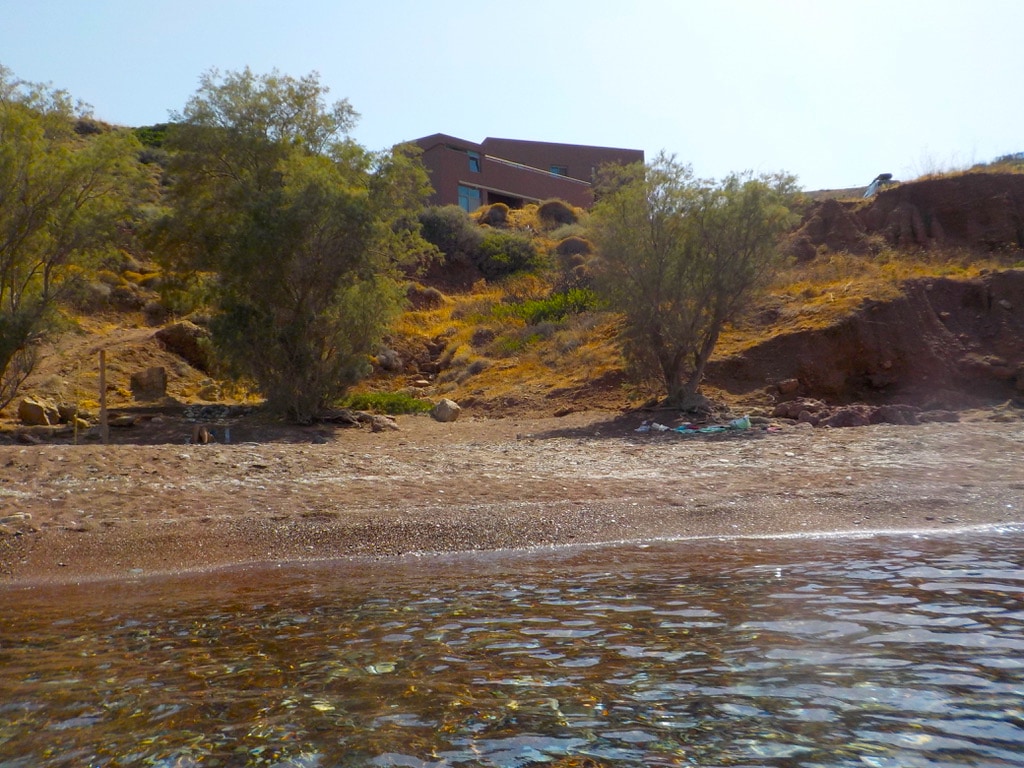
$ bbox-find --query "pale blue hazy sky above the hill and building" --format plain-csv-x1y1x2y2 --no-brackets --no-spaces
0,0,1024,189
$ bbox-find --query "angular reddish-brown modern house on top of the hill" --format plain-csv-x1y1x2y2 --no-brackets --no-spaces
414,133,644,211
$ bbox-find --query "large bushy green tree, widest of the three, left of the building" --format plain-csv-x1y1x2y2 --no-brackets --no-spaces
161,69,428,422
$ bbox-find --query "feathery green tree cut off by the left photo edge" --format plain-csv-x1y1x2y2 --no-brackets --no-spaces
0,67,143,407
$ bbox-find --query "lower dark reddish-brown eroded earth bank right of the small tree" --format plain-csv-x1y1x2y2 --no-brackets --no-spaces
707,270,1024,410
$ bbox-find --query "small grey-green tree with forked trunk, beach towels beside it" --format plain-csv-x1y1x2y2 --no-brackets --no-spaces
590,155,796,409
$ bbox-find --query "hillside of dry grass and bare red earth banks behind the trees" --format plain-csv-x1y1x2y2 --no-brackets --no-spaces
3,173,1024,440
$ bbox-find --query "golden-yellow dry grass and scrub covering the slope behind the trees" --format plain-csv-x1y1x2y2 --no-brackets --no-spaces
4,165,1020,434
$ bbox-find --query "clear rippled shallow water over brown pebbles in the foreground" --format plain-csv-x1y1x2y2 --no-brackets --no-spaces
0,530,1024,768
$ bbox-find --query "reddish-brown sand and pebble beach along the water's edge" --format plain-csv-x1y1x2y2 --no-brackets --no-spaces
0,413,1024,587
